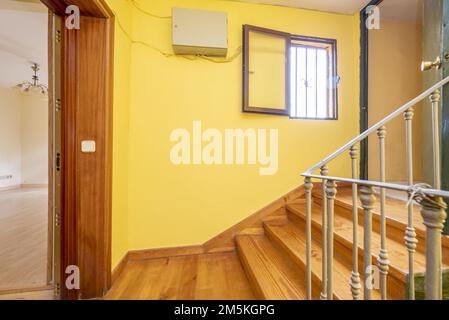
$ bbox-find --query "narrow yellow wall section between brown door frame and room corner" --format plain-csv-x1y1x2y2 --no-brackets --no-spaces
108,0,132,267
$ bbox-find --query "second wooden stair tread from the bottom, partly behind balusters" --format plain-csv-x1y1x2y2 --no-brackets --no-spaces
266,222,380,300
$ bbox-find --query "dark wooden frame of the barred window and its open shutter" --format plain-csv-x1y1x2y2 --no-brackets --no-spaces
242,25,339,120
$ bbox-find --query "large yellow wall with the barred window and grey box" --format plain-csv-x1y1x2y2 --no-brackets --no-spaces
110,0,360,265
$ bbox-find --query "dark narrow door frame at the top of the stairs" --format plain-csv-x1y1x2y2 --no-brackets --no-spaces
360,0,383,180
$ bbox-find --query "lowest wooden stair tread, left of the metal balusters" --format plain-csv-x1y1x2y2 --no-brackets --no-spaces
236,235,306,300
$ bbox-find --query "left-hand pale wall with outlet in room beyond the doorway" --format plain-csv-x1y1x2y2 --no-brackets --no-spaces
0,87,22,188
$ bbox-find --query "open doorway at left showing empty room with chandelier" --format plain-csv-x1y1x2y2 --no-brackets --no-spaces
0,0,54,299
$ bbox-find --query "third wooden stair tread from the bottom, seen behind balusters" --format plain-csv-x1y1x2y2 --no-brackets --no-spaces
287,203,425,281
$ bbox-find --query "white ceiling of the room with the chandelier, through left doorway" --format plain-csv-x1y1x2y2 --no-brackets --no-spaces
0,0,48,87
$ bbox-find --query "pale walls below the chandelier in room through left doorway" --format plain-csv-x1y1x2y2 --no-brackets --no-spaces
0,87,48,188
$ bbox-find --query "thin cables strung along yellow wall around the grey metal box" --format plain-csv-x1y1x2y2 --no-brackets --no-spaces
114,0,242,63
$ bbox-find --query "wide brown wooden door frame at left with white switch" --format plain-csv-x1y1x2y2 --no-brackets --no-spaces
41,0,114,299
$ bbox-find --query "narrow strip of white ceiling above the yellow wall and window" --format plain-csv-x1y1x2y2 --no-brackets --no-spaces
228,0,370,14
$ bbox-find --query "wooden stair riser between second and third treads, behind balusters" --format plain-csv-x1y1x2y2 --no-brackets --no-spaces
288,211,406,300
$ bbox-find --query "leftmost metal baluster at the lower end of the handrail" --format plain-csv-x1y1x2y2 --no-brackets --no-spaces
304,178,313,300
